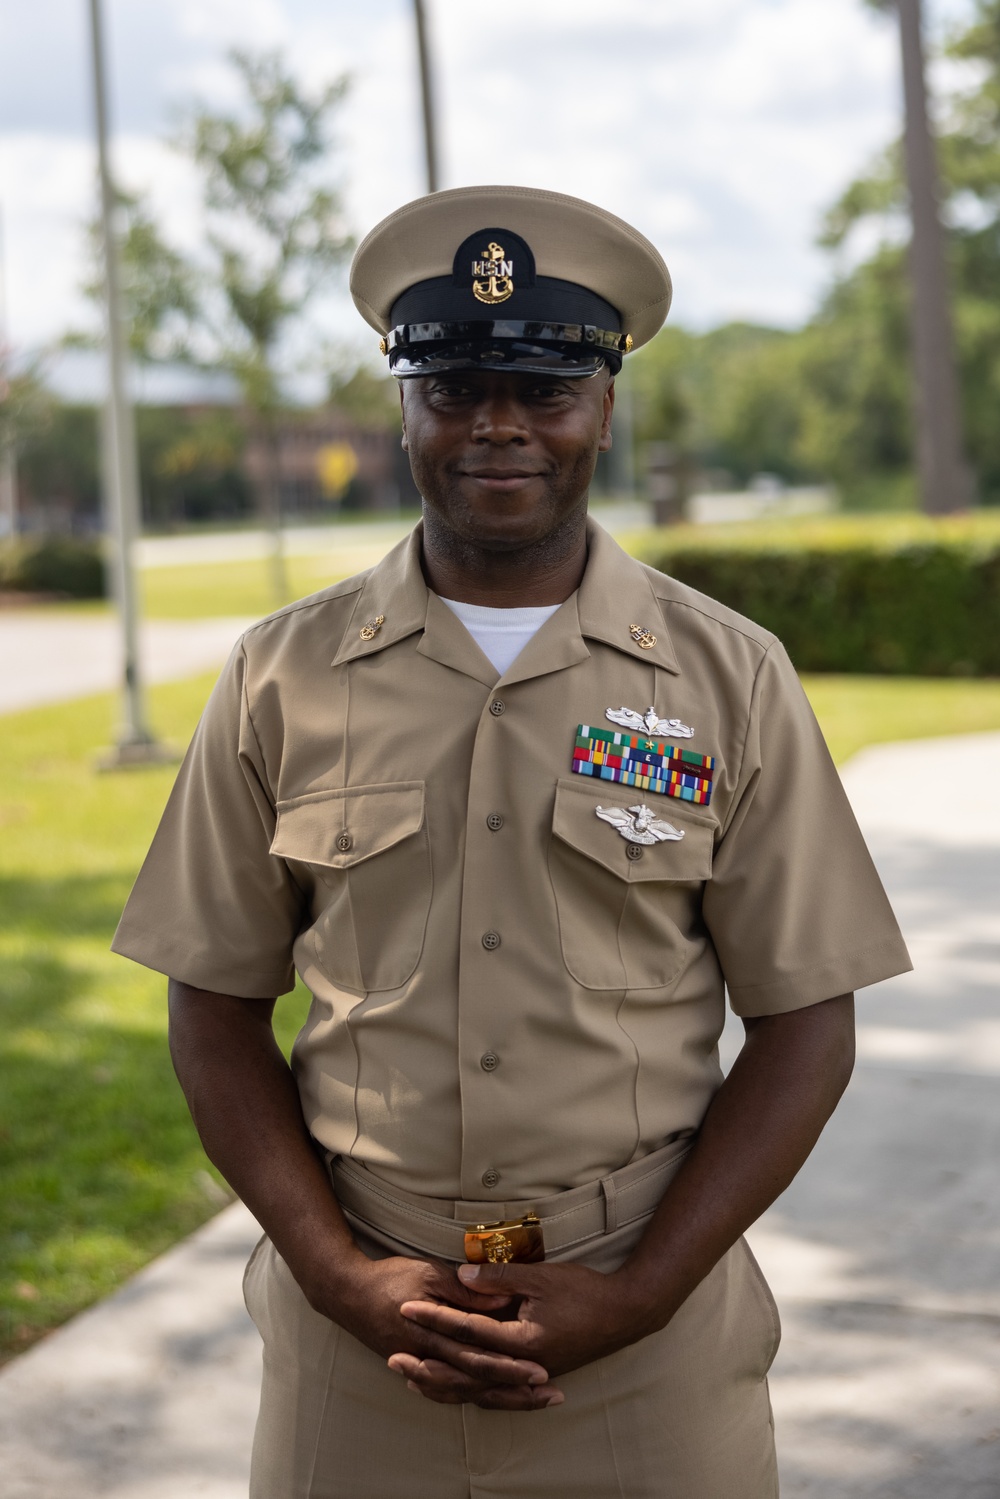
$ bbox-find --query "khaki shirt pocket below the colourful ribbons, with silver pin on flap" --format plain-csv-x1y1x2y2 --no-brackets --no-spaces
549,779,714,989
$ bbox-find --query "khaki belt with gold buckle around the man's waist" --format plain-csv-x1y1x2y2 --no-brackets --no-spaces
327,1133,693,1262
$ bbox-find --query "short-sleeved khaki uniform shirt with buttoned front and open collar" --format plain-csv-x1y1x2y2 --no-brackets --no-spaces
115,525,909,1202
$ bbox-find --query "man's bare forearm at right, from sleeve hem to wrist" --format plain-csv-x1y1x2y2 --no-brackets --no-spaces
618,994,855,1331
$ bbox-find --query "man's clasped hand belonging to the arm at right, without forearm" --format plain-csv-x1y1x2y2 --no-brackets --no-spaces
388,1262,644,1409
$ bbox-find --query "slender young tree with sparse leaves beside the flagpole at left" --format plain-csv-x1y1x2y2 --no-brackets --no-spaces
70,51,357,584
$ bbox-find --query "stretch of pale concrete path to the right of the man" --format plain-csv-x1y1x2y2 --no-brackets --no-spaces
734,735,1000,1499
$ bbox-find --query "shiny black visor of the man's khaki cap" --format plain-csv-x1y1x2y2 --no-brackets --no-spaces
385,318,625,379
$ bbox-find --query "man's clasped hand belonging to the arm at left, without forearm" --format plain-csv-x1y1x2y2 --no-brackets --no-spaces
309,1250,562,1411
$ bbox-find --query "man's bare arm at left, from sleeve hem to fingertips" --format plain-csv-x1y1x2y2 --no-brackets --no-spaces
169,979,562,1411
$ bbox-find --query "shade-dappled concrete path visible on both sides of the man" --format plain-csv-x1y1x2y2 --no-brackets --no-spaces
0,735,1000,1499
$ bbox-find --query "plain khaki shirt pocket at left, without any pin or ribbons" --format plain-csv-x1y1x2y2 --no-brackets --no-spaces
271,781,432,991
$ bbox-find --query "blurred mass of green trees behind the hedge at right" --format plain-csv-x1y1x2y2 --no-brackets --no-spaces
631,0,1000,508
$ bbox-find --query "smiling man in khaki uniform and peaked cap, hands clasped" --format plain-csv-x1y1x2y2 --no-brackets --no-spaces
115,187,909,1499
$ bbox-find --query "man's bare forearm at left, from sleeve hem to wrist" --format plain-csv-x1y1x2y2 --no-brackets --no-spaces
169,979,360,1300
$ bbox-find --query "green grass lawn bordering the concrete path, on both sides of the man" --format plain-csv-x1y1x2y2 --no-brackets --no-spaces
0,668,1000,1357
